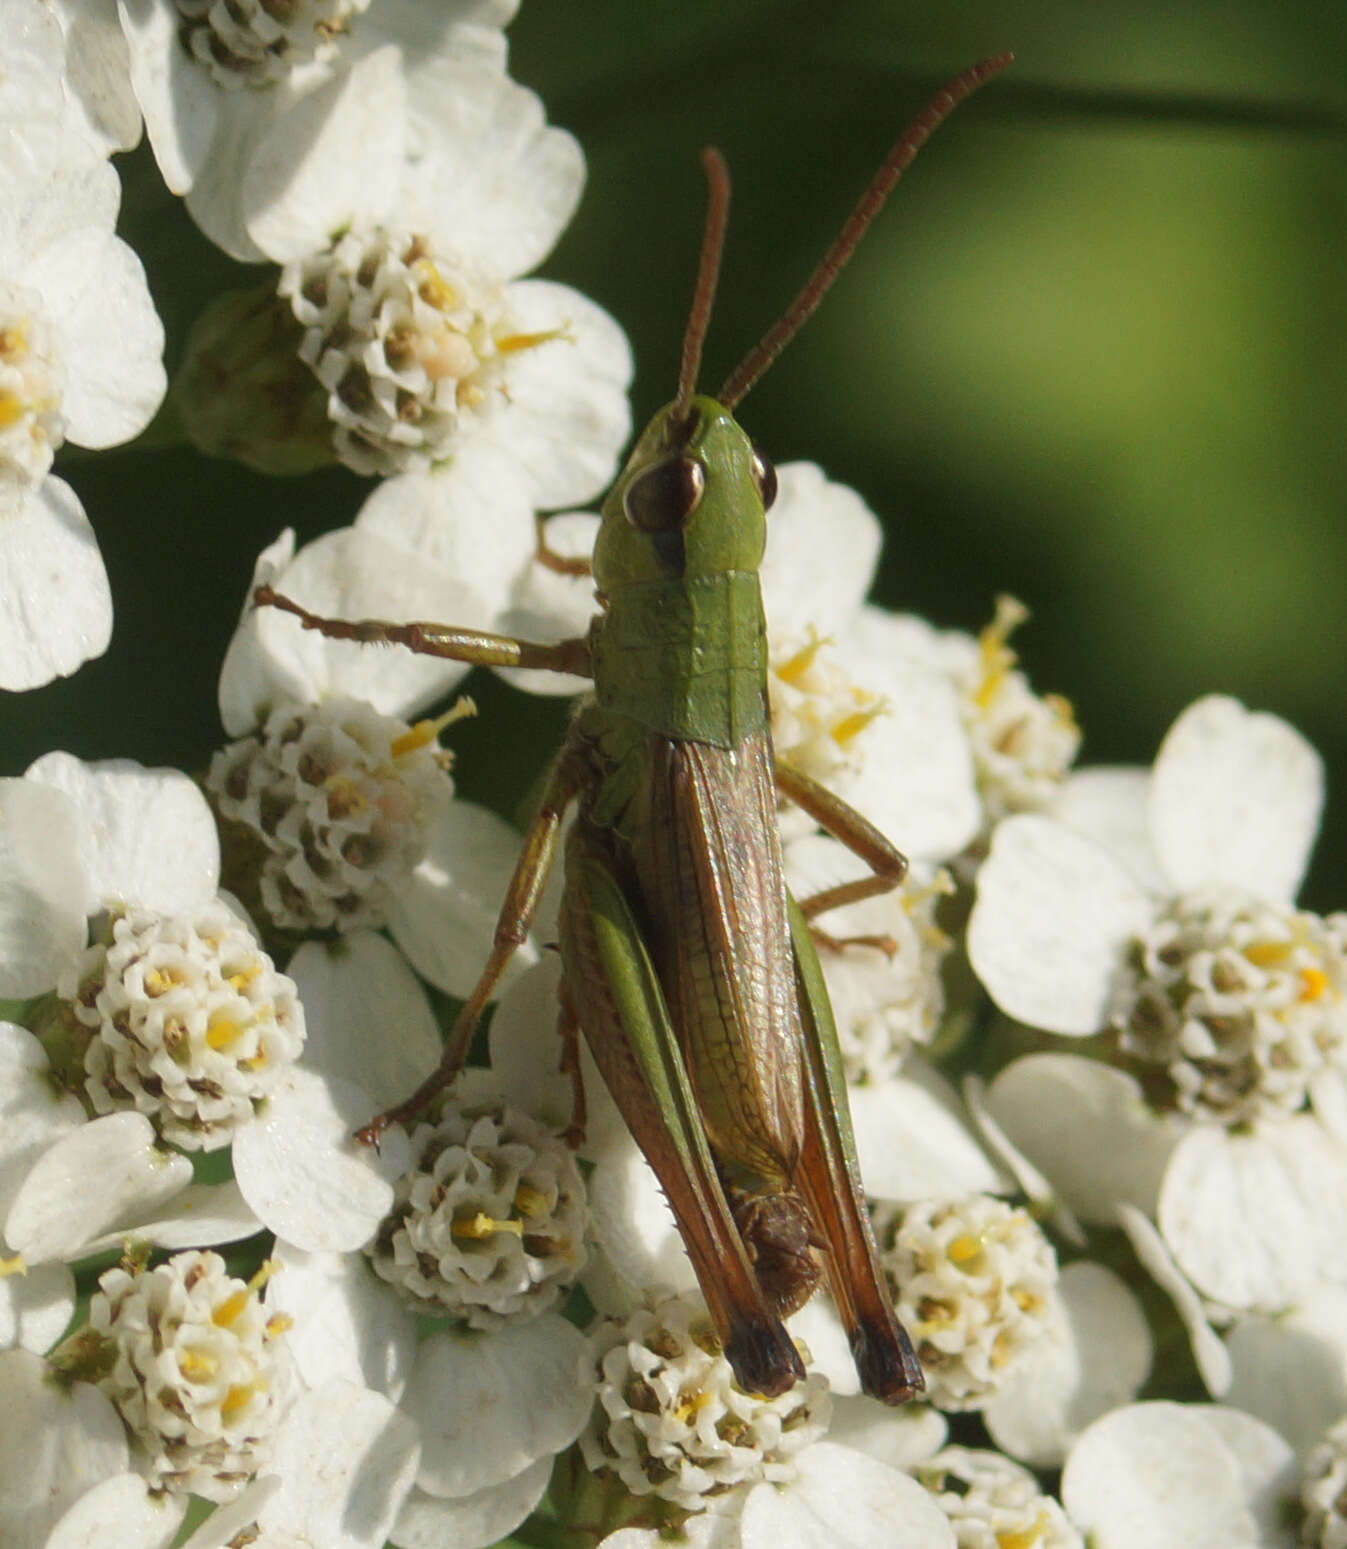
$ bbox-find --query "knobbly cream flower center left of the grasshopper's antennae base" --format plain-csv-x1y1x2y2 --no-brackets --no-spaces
279,231,565,474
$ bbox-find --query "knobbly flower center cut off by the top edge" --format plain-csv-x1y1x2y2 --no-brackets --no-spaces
177,0,370,91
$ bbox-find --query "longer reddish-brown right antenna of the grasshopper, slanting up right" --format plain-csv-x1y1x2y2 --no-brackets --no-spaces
718,53,1014,409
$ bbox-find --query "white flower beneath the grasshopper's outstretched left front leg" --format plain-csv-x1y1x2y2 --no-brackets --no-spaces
211,528,534,991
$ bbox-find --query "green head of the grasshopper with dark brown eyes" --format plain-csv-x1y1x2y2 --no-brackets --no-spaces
595,397,776,595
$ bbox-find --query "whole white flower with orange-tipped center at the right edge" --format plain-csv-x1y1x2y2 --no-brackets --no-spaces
968,697,1347,1310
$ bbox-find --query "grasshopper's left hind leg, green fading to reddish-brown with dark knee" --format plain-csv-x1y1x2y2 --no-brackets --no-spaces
562,842,805,1394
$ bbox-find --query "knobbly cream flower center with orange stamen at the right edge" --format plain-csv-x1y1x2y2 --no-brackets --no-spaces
1112,892,1347,1125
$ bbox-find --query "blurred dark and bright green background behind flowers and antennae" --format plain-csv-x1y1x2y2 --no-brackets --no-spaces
0,0,1347,909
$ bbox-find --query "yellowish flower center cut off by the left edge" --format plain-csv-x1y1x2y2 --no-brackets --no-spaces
0,287,65,496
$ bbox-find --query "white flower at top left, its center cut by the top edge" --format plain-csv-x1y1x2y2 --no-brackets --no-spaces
118,0,516,260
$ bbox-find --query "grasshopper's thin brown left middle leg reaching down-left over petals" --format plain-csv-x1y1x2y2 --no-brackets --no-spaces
356,747,578,1145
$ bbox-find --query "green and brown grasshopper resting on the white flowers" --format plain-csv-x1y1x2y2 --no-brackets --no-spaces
255,54,1009,1403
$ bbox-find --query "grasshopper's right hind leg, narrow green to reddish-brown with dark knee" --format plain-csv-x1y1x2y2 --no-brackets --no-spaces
790,898,926,1403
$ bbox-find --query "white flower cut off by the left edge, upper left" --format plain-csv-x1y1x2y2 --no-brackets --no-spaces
0,0,166,689
